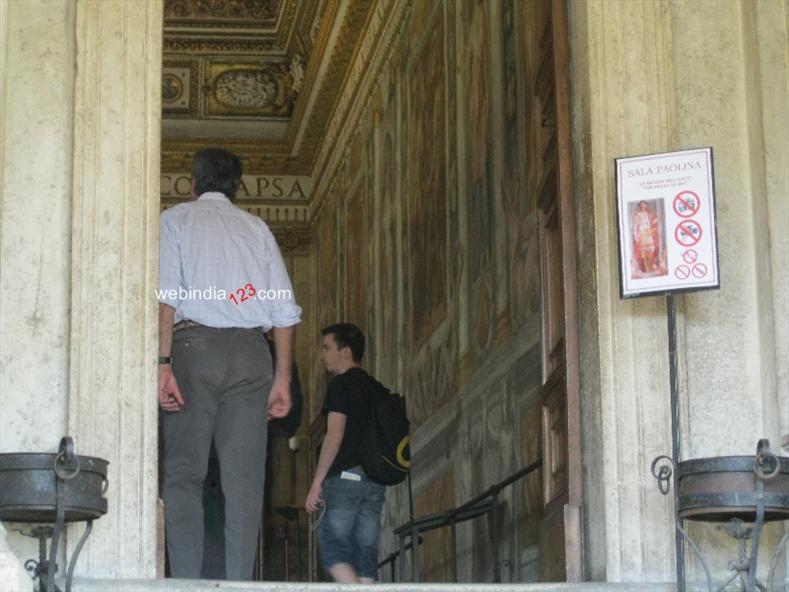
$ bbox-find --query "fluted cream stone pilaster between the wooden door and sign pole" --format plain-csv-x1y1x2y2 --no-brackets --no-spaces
570,1,673,581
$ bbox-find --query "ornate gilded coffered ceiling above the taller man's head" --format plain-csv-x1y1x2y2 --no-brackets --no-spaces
162,0,382,180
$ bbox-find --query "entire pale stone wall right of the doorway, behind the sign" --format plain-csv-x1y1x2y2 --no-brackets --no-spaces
569,1,789,581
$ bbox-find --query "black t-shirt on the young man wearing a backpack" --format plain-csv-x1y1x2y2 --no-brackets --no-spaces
323,367,375,478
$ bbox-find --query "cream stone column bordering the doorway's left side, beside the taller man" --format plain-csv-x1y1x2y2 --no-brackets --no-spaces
68,0,162,577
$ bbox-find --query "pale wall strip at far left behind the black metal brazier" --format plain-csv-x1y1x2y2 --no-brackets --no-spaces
0,1,76,590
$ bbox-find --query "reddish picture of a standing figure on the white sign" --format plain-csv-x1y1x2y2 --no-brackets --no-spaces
627,199,668,280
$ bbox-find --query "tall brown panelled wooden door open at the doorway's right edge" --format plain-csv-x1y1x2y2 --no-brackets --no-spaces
529,0,583,582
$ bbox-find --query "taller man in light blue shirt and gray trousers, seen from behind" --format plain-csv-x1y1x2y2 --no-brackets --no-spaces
157,148,301,580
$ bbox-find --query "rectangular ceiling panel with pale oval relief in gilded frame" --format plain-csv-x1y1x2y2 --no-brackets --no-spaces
205,62,296,117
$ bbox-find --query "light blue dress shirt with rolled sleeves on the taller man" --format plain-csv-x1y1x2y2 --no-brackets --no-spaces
157,192,301,330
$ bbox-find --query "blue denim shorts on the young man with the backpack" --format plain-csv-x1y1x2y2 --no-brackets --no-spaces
318,467,386,579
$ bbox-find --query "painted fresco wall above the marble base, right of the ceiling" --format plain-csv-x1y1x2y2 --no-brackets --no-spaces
315,0,540,425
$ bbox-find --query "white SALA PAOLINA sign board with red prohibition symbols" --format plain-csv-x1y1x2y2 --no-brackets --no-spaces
616,148,720,298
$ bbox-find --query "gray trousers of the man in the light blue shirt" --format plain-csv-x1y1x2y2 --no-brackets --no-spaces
162,327,272,580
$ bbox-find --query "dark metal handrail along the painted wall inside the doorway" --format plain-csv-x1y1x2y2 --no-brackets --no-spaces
378,459,543,583
